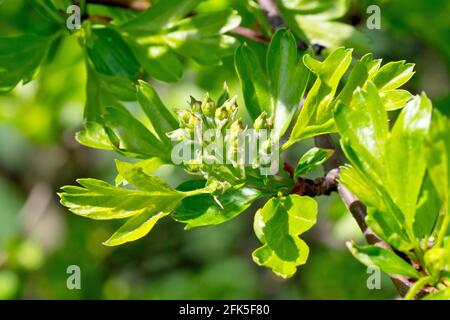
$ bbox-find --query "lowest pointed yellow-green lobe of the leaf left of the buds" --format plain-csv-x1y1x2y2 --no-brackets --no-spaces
103,209,171,246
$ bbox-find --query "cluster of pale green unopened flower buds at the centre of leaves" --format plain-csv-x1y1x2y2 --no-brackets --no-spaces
168,94,273,194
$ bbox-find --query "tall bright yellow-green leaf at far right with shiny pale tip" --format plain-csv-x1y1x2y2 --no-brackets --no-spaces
384,94,432,230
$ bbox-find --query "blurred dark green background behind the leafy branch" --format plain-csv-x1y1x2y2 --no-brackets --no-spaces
0,0,450,299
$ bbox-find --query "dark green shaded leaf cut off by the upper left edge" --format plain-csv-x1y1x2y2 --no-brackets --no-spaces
0,34,50,93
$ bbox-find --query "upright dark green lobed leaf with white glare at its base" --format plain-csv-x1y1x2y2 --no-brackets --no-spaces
235,29,309,139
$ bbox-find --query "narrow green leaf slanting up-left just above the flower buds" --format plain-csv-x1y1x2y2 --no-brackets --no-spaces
137,80,178,143
